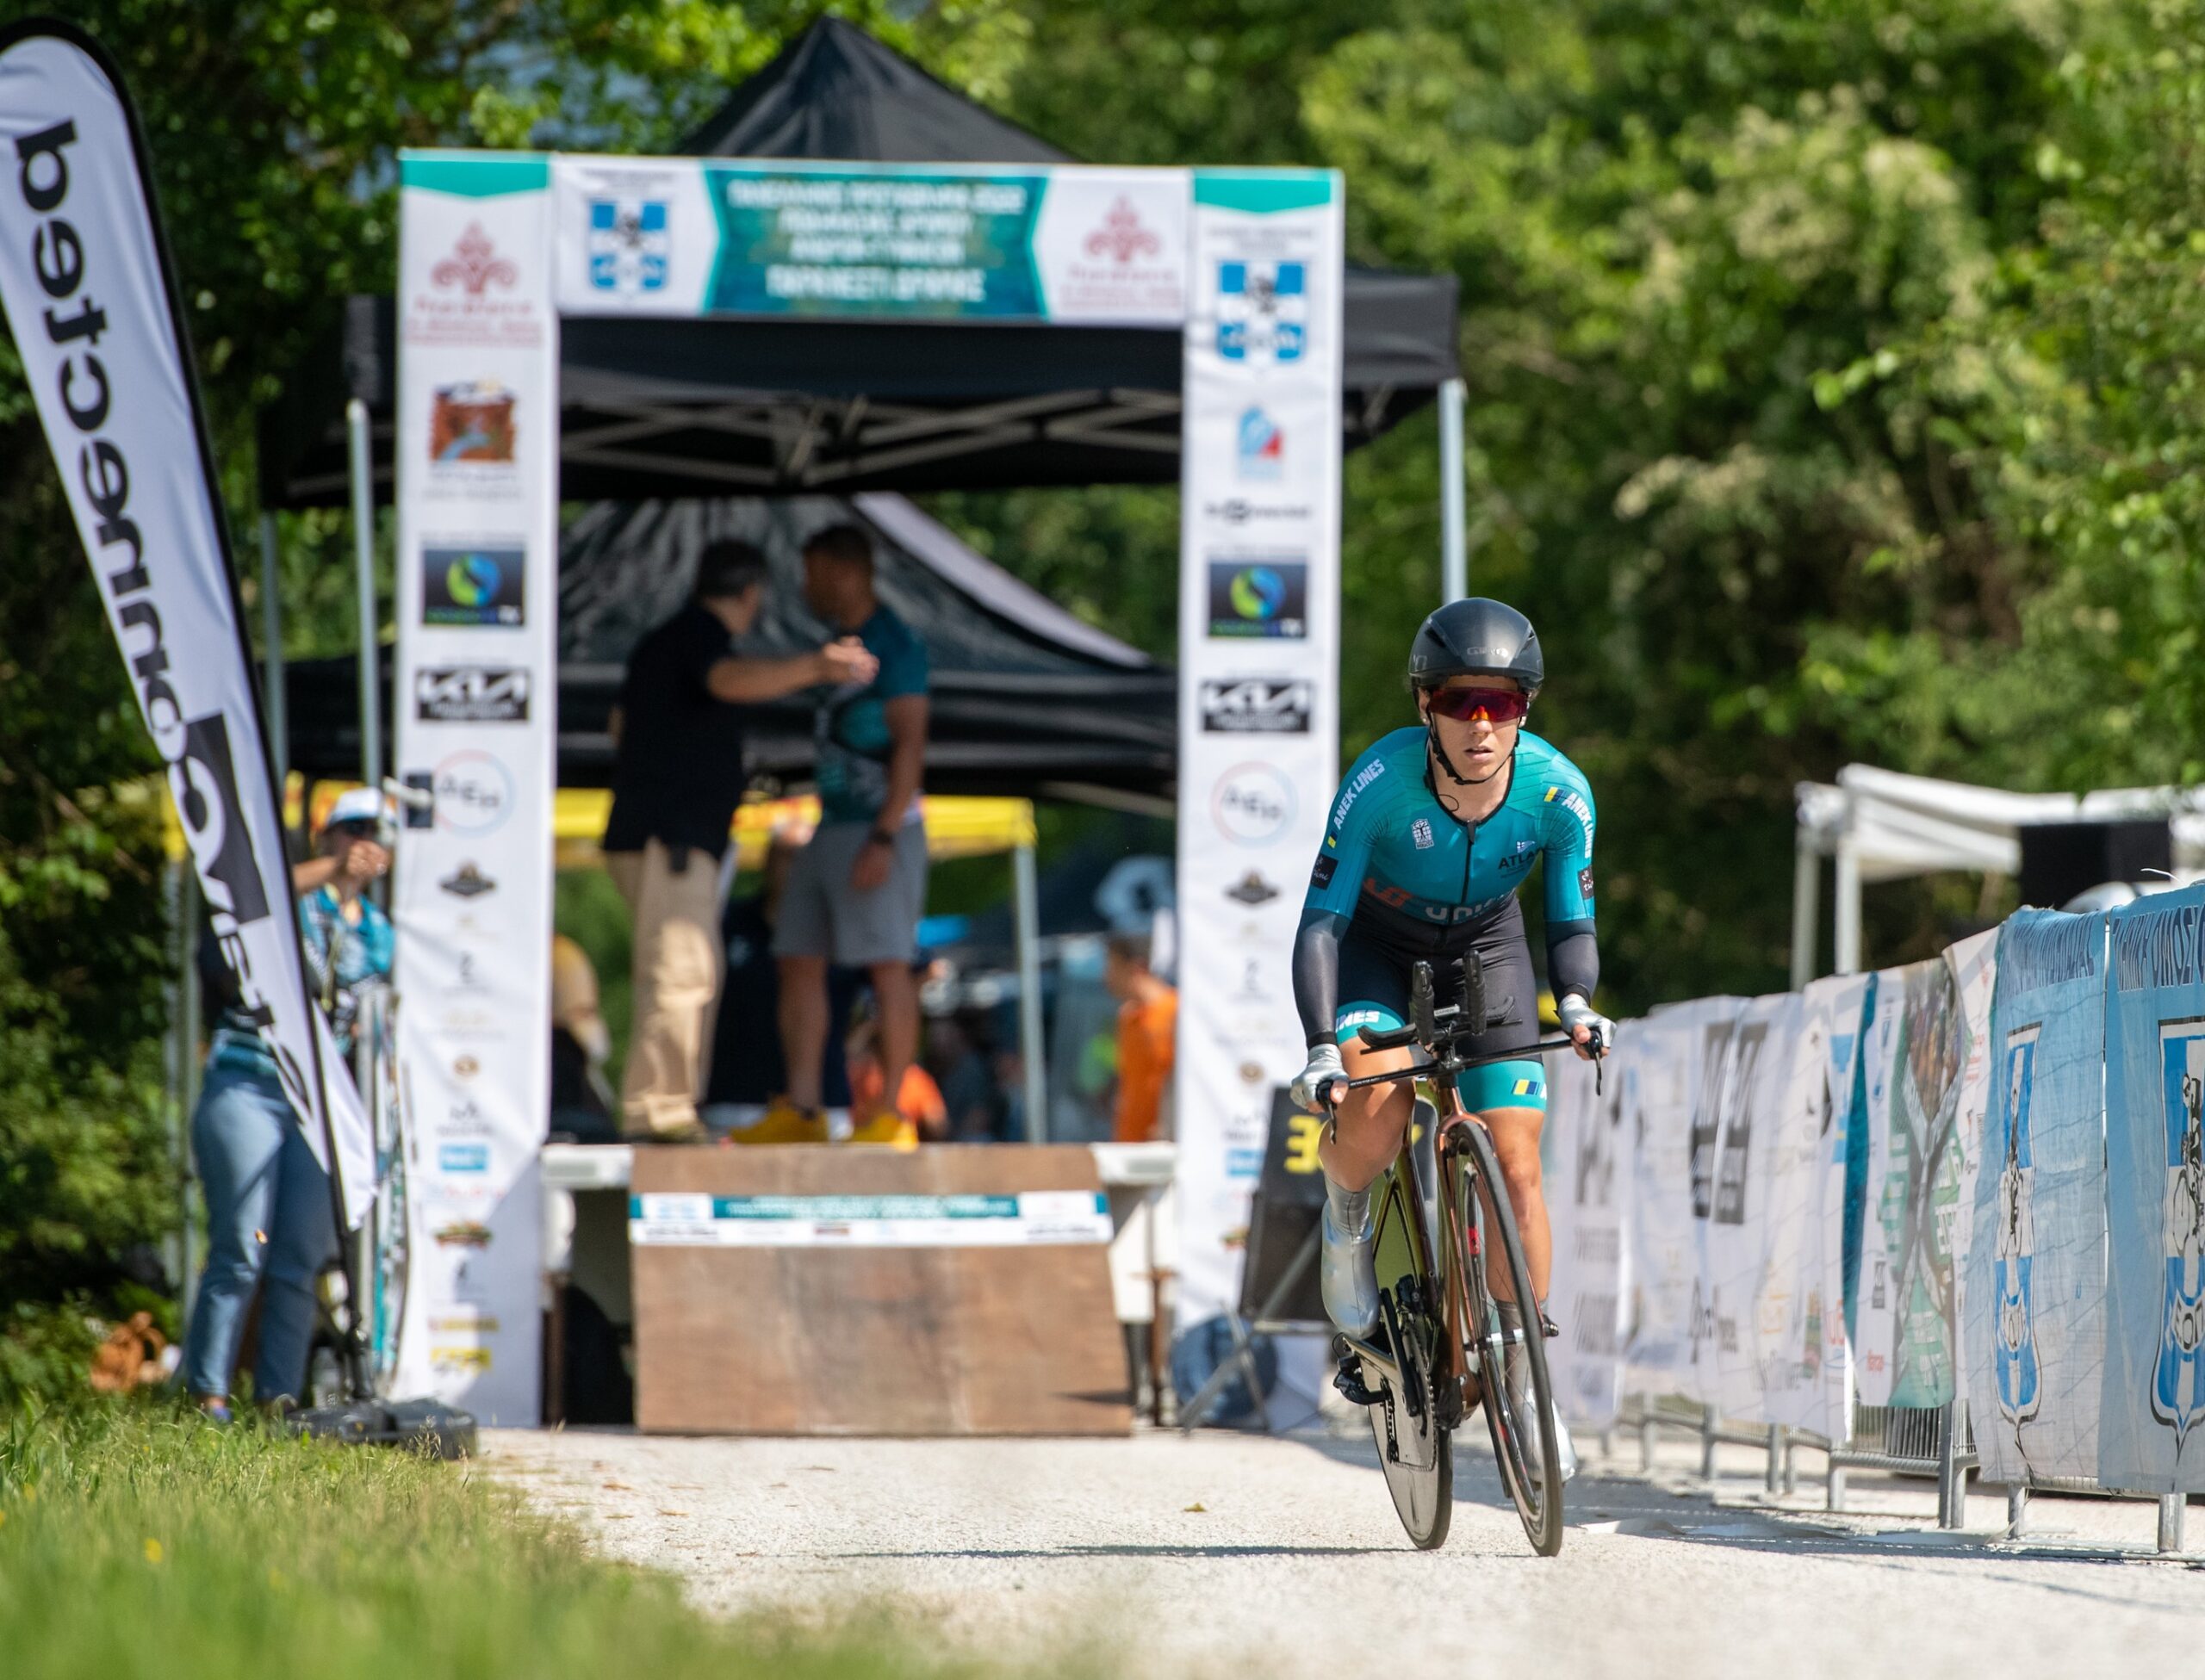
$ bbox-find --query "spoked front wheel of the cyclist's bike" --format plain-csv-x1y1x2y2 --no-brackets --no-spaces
1446,1120,1561,1557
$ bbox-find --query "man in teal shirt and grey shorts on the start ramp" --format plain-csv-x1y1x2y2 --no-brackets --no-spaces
774,524,926,1138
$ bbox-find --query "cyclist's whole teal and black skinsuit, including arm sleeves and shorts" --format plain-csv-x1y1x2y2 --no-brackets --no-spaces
1295,728,1599,1113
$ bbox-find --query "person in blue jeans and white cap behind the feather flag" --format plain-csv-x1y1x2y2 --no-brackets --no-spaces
183,787,393,1422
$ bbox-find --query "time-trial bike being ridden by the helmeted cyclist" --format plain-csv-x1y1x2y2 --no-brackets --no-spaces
1327,961,1575,1557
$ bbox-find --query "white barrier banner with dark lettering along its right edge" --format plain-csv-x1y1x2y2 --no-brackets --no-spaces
1616,996,1747,1402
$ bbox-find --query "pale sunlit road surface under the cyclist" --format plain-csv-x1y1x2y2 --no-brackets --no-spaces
488,1431,2205,1680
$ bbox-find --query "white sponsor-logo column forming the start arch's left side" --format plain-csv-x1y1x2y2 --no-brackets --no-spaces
393,152,558,1424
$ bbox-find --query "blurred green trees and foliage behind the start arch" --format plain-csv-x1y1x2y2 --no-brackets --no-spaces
0,0,2205,1389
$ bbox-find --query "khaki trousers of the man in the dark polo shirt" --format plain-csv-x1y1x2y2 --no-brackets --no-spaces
604,840,728,1140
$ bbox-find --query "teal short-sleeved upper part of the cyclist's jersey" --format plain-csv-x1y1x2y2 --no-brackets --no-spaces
1303,728,1594,948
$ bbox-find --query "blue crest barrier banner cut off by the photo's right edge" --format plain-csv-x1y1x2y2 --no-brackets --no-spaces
2097,886,2205,1492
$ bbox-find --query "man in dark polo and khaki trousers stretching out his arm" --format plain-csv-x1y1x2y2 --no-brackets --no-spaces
604,538,879,1142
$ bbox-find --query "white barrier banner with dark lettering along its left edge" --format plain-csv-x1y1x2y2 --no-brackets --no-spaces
1696,992,1822,1422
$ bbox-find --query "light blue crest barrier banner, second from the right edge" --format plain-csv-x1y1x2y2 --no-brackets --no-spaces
1960,910,2106,1482
